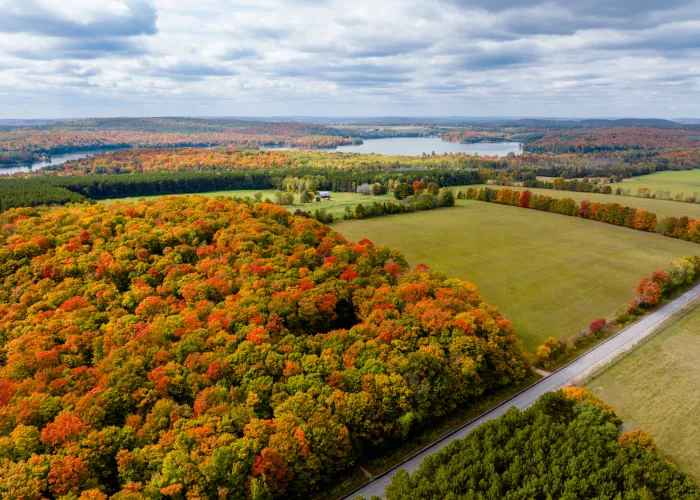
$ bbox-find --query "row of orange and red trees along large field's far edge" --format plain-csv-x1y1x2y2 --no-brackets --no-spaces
457,188,700,243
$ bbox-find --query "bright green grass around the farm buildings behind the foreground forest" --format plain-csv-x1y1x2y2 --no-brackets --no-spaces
100,189,394,219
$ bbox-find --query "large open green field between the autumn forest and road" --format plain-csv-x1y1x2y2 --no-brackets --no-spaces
333,200,700,350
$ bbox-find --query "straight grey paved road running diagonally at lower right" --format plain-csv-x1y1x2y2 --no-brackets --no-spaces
346,285,700,500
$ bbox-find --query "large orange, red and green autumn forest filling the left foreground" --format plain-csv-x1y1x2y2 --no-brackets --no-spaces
0,197,529,499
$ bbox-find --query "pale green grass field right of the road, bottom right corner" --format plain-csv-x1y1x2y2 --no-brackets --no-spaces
587,307,700,481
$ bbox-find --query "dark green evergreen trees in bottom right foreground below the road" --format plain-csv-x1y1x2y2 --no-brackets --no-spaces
370,388,700,500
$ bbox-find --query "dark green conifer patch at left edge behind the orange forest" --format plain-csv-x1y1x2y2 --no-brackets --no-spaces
0,178,87,212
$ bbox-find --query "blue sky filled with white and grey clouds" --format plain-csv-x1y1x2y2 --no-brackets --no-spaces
0,0,700,118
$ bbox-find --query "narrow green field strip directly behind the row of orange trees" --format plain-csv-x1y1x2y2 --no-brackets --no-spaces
452,183,700,219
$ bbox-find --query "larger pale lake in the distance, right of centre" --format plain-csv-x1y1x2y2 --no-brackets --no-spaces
270,137,521,156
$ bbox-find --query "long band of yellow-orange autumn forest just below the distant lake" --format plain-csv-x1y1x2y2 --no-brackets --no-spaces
32,148,700,187
